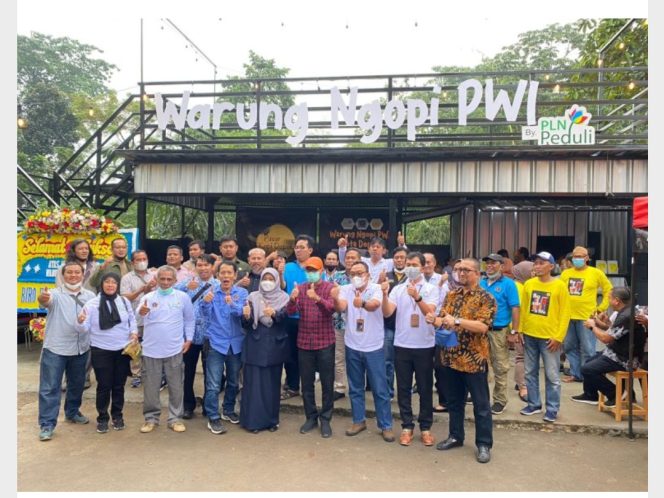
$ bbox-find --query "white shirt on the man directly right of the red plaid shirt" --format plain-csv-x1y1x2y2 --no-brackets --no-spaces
339,283,385,353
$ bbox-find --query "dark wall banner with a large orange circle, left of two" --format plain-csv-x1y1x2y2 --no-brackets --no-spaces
235,208,316,259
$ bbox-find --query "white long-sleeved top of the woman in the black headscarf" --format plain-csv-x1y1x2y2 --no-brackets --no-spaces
76,296,136,351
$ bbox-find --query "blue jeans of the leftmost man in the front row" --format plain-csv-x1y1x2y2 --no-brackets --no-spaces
39,348,90,429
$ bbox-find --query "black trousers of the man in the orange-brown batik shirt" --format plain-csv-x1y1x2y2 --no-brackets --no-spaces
442,367,493,448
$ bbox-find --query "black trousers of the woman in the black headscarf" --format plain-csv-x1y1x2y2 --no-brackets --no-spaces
90,347,129,422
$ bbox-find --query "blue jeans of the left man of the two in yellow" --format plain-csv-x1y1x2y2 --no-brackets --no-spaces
523,334,560,413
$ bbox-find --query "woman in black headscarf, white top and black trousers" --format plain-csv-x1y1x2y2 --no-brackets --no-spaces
76,273,138,434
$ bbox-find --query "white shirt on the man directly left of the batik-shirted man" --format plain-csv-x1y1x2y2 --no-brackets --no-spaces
388,277,440,349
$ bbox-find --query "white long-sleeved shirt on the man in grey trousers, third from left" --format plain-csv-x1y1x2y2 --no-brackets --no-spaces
138,290,195,358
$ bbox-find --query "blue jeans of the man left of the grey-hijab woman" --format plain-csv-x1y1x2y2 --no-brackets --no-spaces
203,348,242,420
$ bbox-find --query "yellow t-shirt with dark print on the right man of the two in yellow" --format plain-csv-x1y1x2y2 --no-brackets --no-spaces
560,266,613,320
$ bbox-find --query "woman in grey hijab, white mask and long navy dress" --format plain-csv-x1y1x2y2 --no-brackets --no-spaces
240,268,289,433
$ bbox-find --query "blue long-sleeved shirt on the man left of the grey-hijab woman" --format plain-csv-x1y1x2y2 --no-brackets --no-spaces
201,285,249,355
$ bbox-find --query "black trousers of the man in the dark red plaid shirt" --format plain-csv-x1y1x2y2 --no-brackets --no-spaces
298,344,334,420
